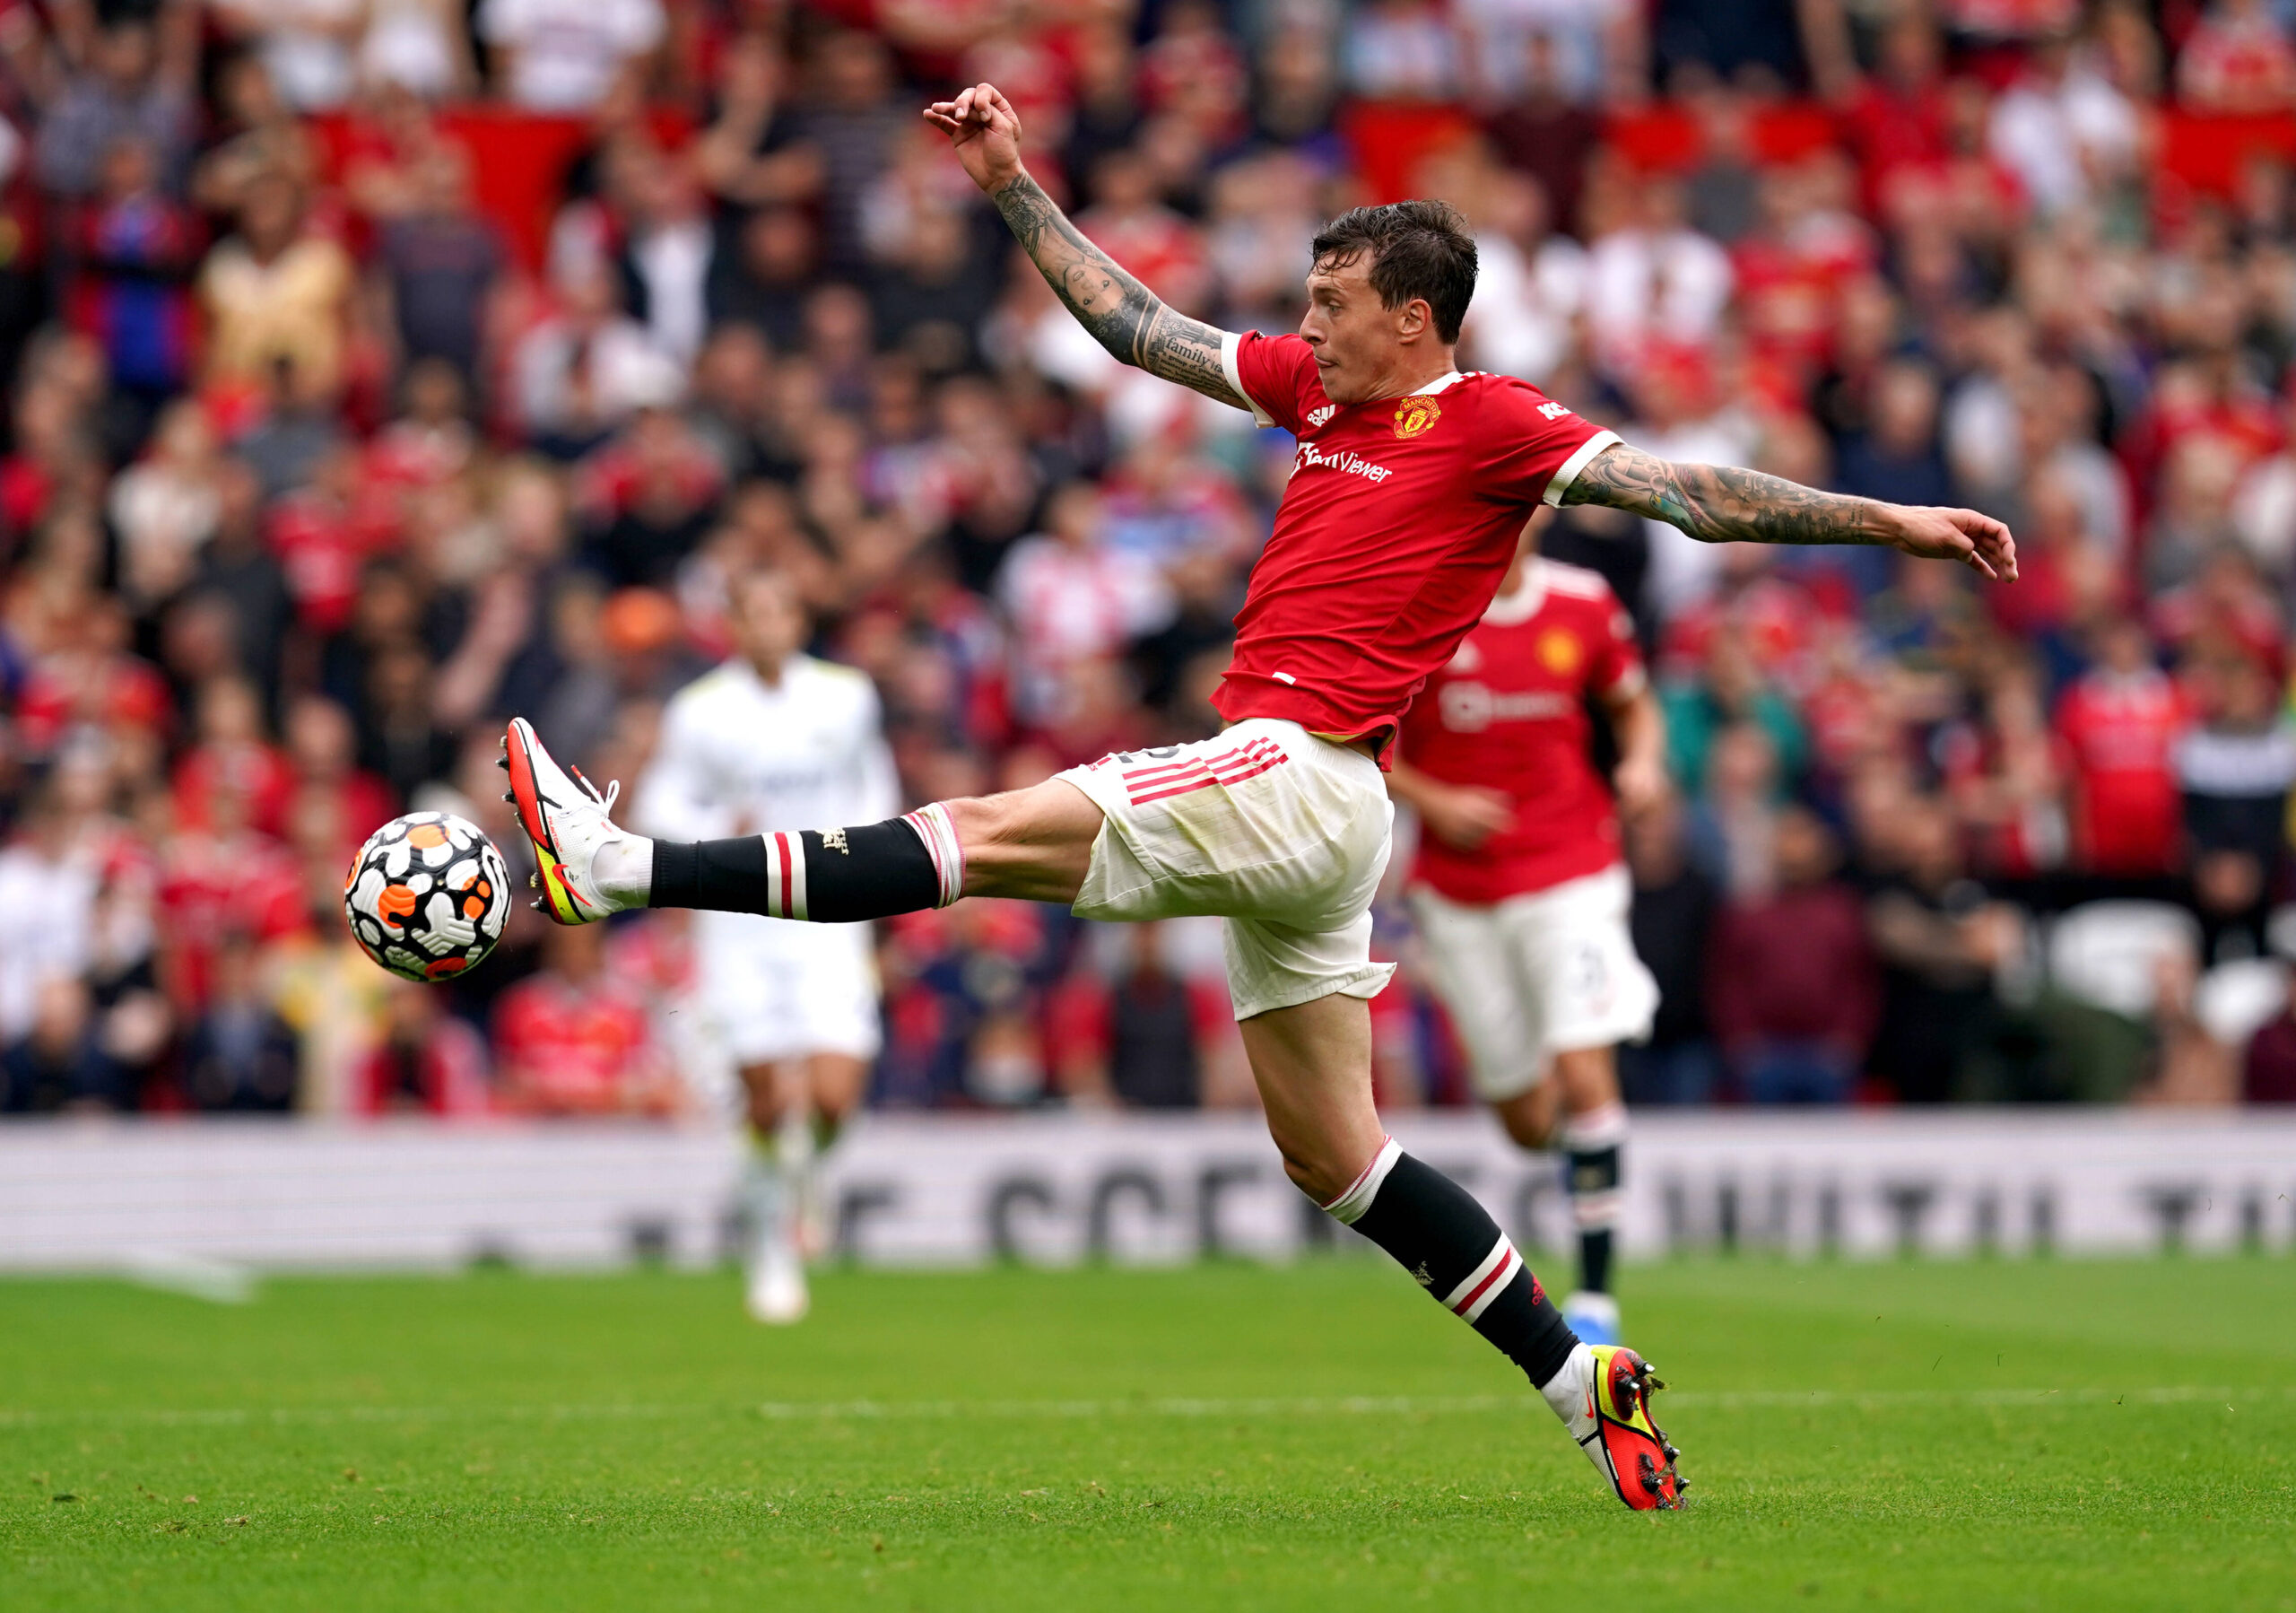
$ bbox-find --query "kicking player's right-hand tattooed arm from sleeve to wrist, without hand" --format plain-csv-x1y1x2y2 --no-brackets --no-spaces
1563,443,1890,545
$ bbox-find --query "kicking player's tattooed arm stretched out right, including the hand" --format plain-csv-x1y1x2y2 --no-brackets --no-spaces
1563,443,2016,581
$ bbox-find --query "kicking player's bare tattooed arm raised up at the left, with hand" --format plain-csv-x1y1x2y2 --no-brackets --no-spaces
926,85,1251,409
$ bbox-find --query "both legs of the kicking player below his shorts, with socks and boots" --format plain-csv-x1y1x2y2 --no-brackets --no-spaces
505,719,1678,1507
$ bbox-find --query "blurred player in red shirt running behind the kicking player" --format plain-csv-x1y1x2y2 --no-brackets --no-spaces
1387,528,1667,1344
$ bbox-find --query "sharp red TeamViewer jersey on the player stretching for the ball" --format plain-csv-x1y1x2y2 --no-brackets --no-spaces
1213,333,1619,763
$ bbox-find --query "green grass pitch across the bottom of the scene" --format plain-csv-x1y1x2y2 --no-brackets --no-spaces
0,1257,2296,1613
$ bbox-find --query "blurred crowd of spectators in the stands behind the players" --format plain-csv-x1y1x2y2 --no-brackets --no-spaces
0,0,2296,1114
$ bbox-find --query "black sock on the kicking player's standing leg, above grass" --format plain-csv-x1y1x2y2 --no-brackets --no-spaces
1323,1138,1578,1388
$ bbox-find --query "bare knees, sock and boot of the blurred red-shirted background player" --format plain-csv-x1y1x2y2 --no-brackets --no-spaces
1490,1045,1628,1344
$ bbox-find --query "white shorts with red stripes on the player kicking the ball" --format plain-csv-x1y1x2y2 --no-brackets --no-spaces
1058,717,1396,1020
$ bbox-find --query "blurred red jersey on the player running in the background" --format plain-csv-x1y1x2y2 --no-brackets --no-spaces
1403,561,1644,905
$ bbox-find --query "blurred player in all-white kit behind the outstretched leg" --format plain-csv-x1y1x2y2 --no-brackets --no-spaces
634,570,900,1321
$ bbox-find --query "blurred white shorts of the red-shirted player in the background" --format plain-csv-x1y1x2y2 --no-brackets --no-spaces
1412,864,1657,1103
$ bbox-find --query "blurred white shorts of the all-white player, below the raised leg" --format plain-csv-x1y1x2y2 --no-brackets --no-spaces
693,912,882,1064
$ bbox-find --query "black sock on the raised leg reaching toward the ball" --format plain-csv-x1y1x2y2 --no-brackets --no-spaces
645,802,964,924
